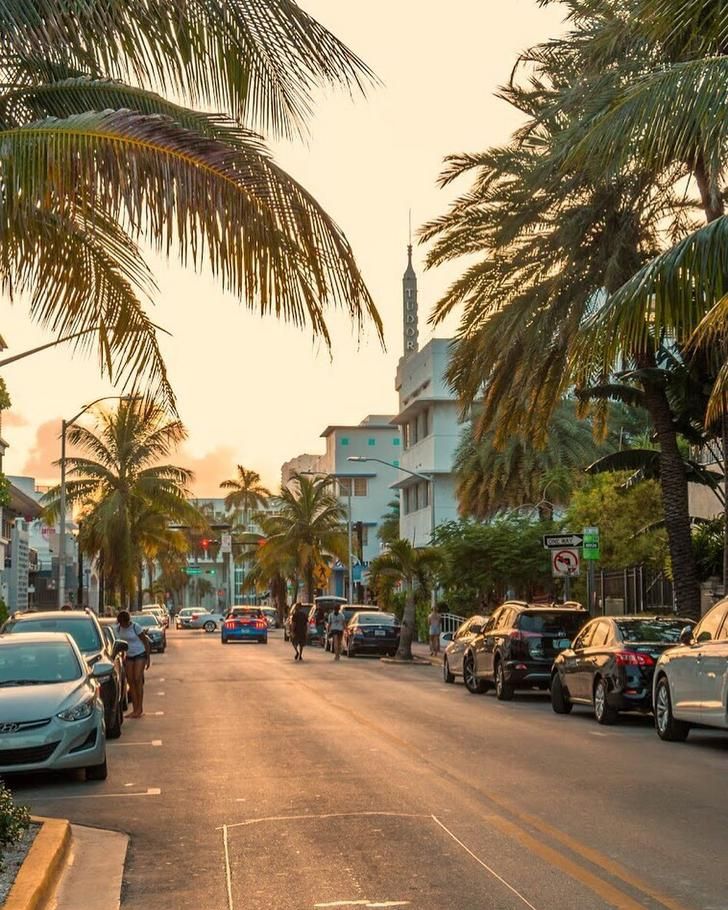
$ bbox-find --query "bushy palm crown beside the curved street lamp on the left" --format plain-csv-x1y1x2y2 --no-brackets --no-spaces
45,399,200,606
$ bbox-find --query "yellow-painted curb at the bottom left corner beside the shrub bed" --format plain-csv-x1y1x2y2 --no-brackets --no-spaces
3,816,71,910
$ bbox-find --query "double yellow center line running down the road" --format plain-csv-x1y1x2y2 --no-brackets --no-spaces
300,683,688,910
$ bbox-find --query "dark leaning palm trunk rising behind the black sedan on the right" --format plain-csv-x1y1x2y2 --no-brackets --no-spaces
640,376,700,619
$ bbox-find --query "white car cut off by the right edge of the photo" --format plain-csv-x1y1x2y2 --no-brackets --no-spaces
652,597,728,742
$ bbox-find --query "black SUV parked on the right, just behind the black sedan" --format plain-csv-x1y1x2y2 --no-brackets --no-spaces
463,600,589,701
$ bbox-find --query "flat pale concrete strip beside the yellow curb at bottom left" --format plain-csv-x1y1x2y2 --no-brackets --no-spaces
49,825,129,910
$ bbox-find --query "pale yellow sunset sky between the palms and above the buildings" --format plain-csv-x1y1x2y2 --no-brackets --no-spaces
0,0,560,496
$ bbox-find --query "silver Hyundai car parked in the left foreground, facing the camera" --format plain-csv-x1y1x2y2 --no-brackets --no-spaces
0,632,113,780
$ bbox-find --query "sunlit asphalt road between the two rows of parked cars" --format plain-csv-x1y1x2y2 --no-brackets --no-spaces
7,632,728,910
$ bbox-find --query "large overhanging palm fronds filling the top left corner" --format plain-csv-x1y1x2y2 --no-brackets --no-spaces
0,0,381,400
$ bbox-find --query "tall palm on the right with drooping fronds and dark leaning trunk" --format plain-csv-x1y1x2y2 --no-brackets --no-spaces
423,0,712,616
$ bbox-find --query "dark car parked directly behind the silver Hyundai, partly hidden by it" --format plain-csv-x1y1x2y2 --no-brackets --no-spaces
0,610,129,739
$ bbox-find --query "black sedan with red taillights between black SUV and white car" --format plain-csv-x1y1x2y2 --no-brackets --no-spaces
551,616,692,724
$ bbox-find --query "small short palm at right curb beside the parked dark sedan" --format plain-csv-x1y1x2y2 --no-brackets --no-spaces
369,538,441,660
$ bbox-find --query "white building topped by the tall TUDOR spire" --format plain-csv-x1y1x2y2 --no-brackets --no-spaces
393,246,462,546
